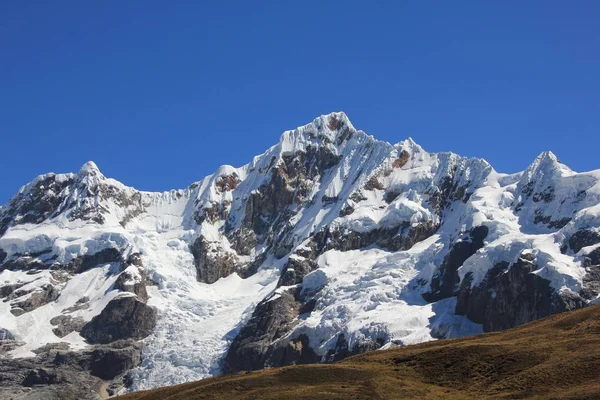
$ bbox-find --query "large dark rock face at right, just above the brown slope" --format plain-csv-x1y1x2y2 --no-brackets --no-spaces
456,253,585,332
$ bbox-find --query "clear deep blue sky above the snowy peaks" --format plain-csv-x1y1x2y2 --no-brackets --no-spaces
0,0,600,204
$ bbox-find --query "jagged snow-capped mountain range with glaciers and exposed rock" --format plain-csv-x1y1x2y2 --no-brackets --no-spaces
0,113,600,398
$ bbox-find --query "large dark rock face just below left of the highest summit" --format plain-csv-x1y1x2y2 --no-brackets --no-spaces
196,142,346,283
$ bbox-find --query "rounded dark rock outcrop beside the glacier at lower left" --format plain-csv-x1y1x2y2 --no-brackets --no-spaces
81,296,156,344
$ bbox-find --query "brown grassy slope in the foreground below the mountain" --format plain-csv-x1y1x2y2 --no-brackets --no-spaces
122,306,600,400
